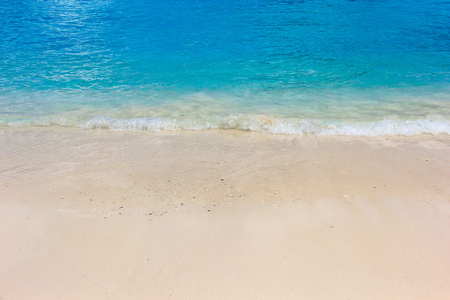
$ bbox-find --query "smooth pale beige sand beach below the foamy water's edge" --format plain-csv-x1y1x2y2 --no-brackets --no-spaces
0,129,450,300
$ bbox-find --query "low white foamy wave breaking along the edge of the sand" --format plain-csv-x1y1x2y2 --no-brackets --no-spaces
0,114,450,136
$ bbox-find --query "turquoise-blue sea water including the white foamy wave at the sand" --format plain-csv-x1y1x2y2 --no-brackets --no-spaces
0,0,450,135
